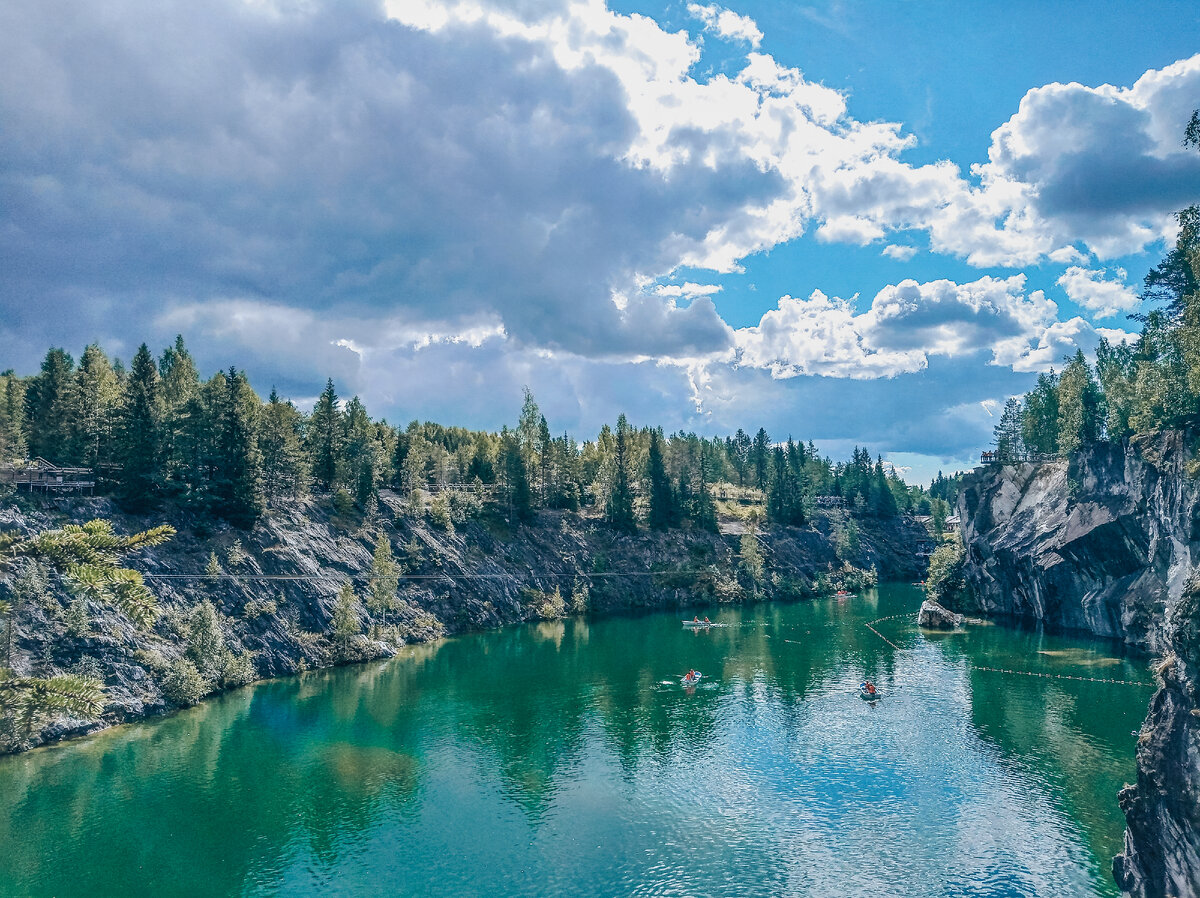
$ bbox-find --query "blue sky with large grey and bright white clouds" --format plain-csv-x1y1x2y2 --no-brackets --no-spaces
0,0,1200,481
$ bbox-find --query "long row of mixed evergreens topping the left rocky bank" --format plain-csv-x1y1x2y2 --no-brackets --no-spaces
0,336,936,532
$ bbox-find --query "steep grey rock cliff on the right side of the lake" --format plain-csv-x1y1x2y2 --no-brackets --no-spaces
956,432,1200,898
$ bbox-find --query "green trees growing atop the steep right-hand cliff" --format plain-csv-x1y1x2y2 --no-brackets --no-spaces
994,112,1200,461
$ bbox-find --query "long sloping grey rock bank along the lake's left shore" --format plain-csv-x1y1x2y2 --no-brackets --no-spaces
0,493,925,749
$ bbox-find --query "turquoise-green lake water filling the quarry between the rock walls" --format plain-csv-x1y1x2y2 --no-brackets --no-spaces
0,586,1151,898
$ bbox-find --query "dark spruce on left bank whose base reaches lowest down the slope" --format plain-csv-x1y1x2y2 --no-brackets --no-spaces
211,367,263,528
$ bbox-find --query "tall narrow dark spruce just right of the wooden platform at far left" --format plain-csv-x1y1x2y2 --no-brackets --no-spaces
116,343,162,510
